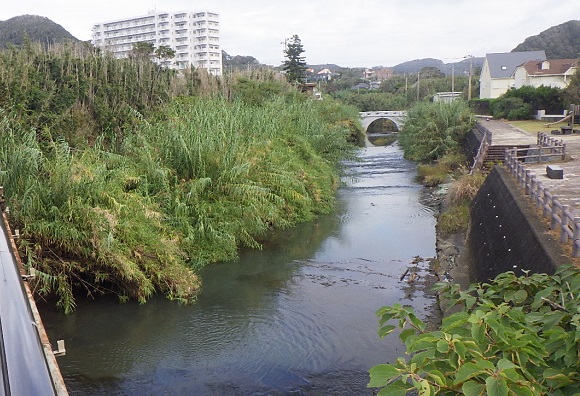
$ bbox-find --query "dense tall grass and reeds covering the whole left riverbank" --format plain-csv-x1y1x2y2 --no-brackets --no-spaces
0,46,358,312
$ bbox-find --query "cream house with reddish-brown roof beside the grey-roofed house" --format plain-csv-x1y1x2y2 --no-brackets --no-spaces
514,59,580,88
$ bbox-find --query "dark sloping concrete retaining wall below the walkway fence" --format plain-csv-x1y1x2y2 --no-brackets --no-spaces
467,166,566,282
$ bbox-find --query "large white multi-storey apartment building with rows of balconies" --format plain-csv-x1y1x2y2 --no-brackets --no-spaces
92,11,222,76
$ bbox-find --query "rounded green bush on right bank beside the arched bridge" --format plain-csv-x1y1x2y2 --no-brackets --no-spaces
399,101,475,161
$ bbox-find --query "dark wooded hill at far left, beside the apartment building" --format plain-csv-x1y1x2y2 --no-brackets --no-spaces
0,15,79,48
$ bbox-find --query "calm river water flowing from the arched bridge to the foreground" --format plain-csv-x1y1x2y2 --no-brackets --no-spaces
40,146,435,395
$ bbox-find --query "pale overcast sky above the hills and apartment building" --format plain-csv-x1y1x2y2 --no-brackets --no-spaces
0,0,580,67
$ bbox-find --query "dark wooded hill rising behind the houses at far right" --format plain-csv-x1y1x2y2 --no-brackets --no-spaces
512,20,580,59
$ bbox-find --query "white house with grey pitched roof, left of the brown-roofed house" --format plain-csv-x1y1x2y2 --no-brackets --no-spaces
479,51,546,99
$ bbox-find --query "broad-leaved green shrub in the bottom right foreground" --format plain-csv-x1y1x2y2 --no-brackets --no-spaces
369,267,580,396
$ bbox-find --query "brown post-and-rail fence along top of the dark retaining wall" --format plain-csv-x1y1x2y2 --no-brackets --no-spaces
505,148,580,257
